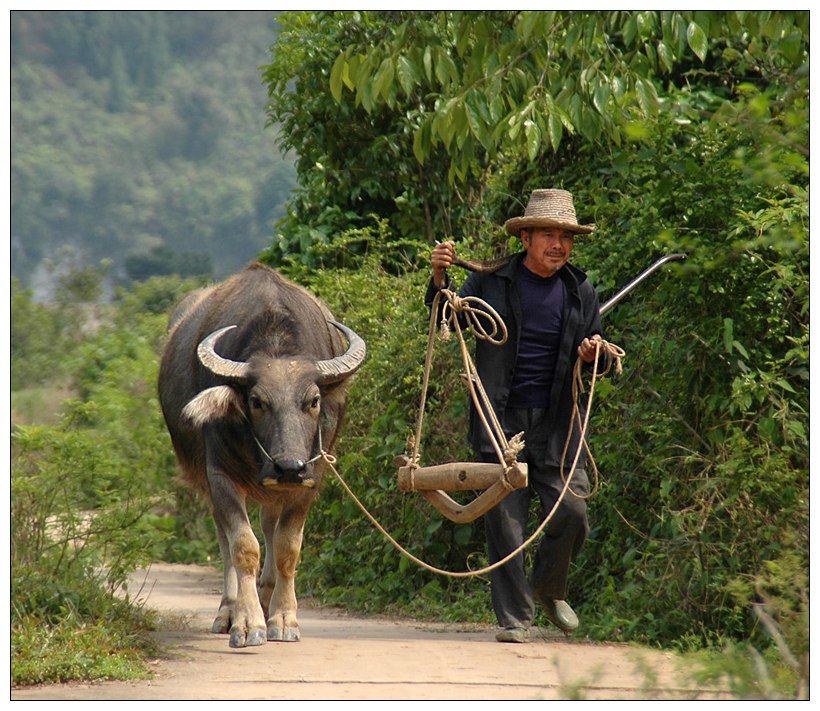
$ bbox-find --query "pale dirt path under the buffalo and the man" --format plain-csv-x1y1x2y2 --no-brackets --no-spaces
11,564,716,701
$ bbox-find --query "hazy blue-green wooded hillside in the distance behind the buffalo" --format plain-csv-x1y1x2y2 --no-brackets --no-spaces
10,11,295,294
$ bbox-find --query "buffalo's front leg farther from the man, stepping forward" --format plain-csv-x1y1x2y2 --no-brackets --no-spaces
208,467,267,647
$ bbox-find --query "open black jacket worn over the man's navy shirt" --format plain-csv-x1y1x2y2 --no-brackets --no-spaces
425,252,607,470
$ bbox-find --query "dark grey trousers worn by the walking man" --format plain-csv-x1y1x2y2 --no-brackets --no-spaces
479,409,589,627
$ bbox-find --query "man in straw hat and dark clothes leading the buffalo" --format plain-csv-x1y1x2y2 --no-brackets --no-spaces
426,190,607,642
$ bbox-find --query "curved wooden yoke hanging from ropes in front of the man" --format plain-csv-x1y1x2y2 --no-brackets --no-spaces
396,456,527,523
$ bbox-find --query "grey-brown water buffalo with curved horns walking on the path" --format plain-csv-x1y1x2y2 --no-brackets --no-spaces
159,263,365,647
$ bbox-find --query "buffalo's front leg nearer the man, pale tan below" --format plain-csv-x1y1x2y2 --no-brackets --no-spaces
259,506,307,642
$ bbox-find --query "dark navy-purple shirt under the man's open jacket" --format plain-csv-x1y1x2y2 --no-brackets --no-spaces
507,264,564,408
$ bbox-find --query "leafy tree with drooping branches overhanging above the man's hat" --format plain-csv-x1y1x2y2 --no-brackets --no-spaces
264,11,808,260
